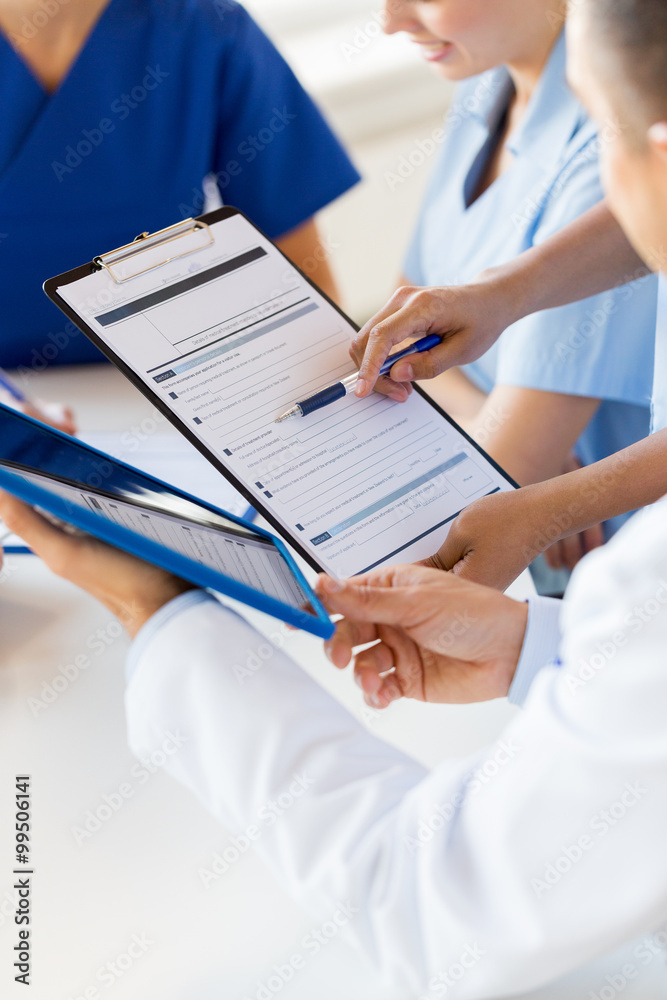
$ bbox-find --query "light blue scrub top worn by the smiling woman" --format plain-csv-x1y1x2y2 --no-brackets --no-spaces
405,36,667,534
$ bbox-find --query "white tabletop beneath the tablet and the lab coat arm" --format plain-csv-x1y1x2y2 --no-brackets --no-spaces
0,366,667,1000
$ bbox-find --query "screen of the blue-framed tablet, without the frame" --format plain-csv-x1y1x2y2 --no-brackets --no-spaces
0,410,308,608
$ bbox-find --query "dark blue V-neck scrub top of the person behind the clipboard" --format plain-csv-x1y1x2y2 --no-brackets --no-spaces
0,0,358,369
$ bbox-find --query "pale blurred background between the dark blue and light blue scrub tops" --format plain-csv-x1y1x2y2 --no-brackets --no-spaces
246,0,451,322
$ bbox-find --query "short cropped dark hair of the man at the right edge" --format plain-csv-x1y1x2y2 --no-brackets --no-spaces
588,0,667,127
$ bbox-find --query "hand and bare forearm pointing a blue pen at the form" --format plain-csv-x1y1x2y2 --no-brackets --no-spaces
350,204,648,397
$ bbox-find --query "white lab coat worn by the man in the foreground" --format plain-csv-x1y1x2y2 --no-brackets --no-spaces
127,511,667,1000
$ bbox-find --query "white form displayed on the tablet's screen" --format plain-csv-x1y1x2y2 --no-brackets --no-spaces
4,467,307,608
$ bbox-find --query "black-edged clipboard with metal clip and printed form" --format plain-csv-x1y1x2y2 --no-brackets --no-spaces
44,206,517,576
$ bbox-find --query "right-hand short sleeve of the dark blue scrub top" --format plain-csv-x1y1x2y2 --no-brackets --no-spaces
215,5,359,239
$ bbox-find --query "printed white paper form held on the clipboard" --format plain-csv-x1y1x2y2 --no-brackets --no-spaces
59,215,512,577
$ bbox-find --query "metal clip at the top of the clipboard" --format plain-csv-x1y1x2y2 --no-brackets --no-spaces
93,219,214,285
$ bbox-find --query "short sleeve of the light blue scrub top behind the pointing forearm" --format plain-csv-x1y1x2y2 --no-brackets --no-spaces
496,139,657,406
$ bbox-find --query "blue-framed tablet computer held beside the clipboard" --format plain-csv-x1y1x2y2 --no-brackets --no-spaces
0,404,334,638
